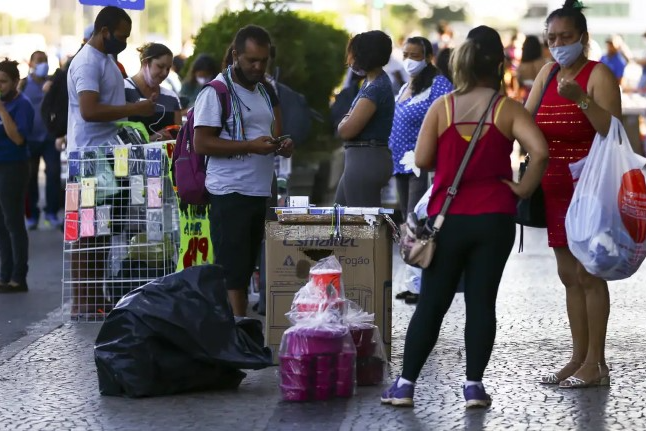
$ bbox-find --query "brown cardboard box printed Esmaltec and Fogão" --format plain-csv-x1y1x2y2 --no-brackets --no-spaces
265,215,392,363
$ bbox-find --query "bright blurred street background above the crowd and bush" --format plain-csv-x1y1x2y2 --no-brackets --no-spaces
0,0,646,85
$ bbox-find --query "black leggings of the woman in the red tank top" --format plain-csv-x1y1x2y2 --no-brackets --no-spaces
402,214,516,382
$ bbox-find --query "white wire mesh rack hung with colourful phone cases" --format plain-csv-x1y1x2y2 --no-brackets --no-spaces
63,143,179,321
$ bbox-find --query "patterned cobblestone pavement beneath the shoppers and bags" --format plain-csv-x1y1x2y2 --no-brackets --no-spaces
0,230,646,431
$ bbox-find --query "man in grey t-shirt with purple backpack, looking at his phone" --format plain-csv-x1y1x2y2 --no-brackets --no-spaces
194,25,293,316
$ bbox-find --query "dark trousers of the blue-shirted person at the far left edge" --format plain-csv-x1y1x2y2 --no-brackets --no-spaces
0,161,29,283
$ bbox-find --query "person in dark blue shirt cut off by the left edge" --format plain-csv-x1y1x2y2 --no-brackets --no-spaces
0,59,34,293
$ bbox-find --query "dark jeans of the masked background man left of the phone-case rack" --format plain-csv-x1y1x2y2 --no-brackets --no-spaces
27,139,61,220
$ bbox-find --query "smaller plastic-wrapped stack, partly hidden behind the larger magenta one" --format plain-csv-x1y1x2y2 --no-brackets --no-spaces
343,301,388,386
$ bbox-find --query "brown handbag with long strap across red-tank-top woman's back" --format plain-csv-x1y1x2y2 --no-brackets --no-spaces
399,92,498,269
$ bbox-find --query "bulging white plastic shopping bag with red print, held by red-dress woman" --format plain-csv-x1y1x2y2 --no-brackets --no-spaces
565,117,646,280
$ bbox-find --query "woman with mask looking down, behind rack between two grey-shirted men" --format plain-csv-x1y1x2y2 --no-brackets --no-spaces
124,43,182,141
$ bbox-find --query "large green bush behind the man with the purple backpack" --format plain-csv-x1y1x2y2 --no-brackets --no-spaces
187,7,349,118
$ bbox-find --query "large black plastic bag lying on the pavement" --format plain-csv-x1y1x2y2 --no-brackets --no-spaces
94,265,272,397
